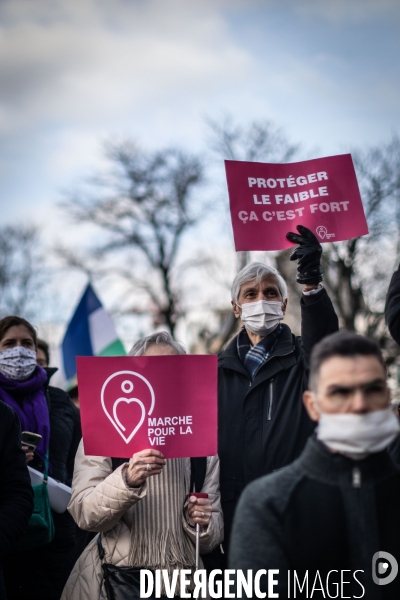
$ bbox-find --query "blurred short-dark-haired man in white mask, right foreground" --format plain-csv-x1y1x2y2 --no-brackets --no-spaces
230,331,400,600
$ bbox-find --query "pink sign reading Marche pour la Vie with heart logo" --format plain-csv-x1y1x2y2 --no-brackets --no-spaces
77,356,217,458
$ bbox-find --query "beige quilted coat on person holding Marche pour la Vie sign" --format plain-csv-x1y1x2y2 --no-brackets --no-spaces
61,442,223,600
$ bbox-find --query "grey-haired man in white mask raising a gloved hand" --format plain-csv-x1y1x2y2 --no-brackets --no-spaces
218,225,338,551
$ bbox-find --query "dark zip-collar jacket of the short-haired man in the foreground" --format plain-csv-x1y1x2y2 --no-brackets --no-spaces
229,436,400,600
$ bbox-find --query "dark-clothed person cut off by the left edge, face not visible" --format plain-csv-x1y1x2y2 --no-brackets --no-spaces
0,401,33,600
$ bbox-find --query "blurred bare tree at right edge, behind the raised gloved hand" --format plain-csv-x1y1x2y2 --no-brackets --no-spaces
276,135,400,363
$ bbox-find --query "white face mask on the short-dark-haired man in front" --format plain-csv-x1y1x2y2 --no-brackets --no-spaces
317,407,400,459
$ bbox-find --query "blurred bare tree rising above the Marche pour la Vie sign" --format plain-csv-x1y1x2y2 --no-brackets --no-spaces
63,141,203,334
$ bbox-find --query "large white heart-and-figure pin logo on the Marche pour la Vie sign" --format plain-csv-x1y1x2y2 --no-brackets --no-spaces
101,371,155,444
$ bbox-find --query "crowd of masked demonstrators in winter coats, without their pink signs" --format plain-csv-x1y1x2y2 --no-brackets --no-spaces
0,226,400,600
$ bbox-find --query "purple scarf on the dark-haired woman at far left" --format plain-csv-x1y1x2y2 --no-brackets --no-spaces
0,366,50,461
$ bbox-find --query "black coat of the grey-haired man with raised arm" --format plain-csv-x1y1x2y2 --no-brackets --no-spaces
218,290,338,547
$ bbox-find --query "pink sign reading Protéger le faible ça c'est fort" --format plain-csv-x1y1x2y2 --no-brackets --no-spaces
225,154,368,251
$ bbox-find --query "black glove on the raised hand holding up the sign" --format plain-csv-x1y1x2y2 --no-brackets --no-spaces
286,225,324,285
